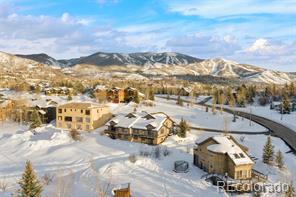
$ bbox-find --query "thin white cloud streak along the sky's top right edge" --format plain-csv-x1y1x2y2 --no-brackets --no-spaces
167,0,296,18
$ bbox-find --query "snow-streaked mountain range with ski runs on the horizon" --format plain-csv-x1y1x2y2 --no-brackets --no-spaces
0,52,296,84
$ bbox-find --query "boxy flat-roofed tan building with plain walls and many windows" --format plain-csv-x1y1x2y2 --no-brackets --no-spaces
56,102,109,131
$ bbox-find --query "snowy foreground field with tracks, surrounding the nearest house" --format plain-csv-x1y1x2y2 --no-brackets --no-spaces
0,123,296,197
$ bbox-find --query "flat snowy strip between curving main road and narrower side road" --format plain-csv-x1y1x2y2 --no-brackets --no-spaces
113,98,266,132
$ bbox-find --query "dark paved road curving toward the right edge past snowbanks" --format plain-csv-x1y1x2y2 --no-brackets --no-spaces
160,97,296,153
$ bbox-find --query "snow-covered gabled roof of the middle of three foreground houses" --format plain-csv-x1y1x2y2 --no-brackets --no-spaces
107,112,168,131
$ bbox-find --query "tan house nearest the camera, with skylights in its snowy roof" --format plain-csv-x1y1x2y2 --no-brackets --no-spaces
194,135,254,180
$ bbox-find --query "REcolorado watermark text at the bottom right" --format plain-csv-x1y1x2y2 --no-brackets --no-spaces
216,181,290,193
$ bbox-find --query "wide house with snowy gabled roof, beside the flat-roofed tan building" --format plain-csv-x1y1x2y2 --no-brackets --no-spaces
105,112,174,145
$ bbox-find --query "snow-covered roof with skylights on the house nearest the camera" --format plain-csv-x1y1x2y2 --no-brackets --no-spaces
207,135,254,165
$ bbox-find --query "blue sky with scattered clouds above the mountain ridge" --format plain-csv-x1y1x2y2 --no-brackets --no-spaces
0,0,296,71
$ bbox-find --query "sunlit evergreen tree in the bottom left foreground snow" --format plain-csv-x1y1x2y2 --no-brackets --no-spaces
18,161,43,197
